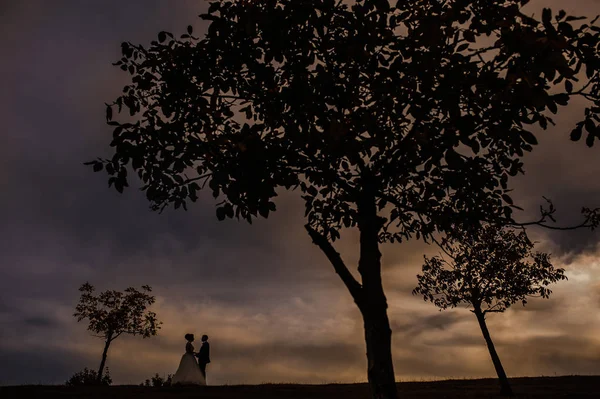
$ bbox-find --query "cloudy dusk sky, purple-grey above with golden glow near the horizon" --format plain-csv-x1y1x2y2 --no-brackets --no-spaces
0,0,600,385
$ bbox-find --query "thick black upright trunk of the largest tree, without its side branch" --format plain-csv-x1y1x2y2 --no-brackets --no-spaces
355,184,398,399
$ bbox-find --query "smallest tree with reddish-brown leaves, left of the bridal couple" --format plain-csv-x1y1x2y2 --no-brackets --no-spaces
73,283,162,383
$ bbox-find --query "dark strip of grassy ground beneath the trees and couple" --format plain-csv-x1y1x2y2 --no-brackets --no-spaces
0,376,600,399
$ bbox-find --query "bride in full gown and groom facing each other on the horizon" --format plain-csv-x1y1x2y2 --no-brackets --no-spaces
173,334,210,385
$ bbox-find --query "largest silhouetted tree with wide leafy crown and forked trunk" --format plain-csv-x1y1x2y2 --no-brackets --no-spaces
89,0,600,398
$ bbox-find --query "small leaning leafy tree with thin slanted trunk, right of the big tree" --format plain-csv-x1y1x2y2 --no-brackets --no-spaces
413,226,567,396
